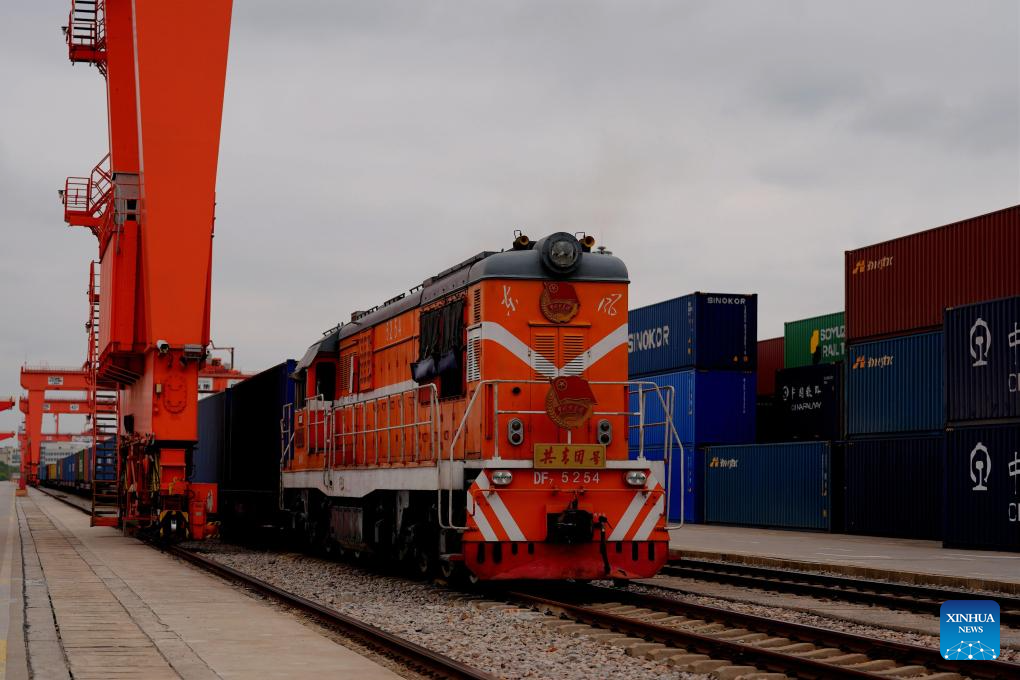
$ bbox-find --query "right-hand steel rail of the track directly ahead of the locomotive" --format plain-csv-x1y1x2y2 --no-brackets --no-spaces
554,586,1020,680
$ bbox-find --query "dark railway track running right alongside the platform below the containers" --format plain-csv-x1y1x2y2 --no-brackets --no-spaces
660,558,1020,628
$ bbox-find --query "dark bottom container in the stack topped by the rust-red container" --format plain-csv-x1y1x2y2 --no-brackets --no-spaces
844,433,945,540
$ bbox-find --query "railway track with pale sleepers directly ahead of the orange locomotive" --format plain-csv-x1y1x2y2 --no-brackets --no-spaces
505,586,1020,680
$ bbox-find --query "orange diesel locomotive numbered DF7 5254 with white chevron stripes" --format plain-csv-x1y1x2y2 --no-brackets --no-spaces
281,232,671,580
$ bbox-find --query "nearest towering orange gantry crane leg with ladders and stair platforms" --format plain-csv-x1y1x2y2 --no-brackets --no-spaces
61,0,232,537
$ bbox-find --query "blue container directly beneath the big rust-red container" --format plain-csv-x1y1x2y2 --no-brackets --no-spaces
847,332,945,436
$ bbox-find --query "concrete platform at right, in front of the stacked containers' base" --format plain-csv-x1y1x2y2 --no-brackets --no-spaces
669,524,1020,594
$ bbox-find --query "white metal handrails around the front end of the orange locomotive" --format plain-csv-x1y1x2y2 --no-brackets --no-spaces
436,379,684,531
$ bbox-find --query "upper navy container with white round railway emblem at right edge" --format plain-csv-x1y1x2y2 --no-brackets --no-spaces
945,298,1020,423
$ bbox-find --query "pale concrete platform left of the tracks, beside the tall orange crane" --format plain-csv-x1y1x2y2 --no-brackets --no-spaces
0,482,400,680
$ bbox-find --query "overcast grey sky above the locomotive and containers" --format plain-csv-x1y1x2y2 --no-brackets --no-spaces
0,0,1020,436
